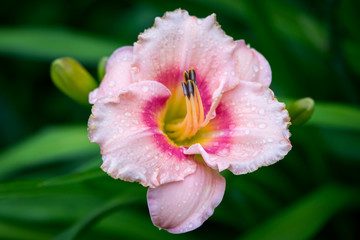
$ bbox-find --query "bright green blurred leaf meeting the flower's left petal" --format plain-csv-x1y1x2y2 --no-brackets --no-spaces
0,125,99,178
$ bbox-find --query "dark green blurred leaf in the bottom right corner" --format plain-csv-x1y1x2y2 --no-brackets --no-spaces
239,185,360,240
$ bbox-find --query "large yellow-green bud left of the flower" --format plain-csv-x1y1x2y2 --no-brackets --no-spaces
50,58,98,105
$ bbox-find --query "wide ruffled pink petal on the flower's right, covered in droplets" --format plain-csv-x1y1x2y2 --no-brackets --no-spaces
185,81,291,174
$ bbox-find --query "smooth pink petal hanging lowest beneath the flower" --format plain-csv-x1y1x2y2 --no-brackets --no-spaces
147,163,225,233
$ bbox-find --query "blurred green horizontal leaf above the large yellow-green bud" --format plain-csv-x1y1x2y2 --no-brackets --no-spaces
0,28,119,65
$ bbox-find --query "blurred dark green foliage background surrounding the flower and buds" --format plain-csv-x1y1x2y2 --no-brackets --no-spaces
0,0,360,239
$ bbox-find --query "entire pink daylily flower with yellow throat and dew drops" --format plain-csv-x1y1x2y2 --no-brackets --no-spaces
88,10,291,233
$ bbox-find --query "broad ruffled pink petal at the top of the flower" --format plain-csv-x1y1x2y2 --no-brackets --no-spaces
133,10,239,113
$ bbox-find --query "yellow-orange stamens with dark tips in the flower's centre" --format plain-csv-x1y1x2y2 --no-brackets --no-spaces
165,69,204,142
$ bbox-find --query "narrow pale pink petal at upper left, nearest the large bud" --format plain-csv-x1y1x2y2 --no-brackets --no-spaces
89,47,133,104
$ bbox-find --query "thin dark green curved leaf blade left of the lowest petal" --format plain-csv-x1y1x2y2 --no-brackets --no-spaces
54,195,140,240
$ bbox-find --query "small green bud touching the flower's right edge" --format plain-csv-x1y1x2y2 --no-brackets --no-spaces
287,97,315,125
